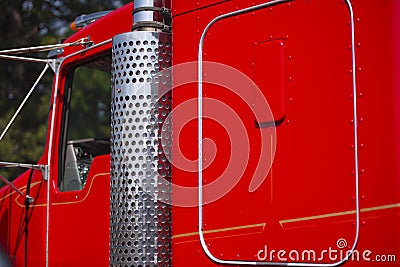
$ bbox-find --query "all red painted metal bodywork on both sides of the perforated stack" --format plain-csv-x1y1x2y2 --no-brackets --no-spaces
0,0,400,266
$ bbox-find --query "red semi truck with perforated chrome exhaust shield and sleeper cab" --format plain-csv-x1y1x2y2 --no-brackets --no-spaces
0,0,400,266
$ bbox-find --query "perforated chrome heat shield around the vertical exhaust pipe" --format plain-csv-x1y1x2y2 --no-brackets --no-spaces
110,31,172,266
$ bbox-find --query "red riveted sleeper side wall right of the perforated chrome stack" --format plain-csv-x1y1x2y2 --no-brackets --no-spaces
173,1,400,266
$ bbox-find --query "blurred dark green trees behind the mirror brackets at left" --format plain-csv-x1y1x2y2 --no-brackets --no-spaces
0,0,131,180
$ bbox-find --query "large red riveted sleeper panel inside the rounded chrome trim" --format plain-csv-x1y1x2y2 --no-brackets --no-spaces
199,1,358,264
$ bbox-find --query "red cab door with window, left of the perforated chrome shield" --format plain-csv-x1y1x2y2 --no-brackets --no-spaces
49,53,111,266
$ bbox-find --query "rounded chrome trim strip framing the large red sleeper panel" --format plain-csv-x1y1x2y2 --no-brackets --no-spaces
197,0,360,267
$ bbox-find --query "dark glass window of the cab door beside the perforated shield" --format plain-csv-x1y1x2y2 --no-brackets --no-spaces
58,55,111,191
